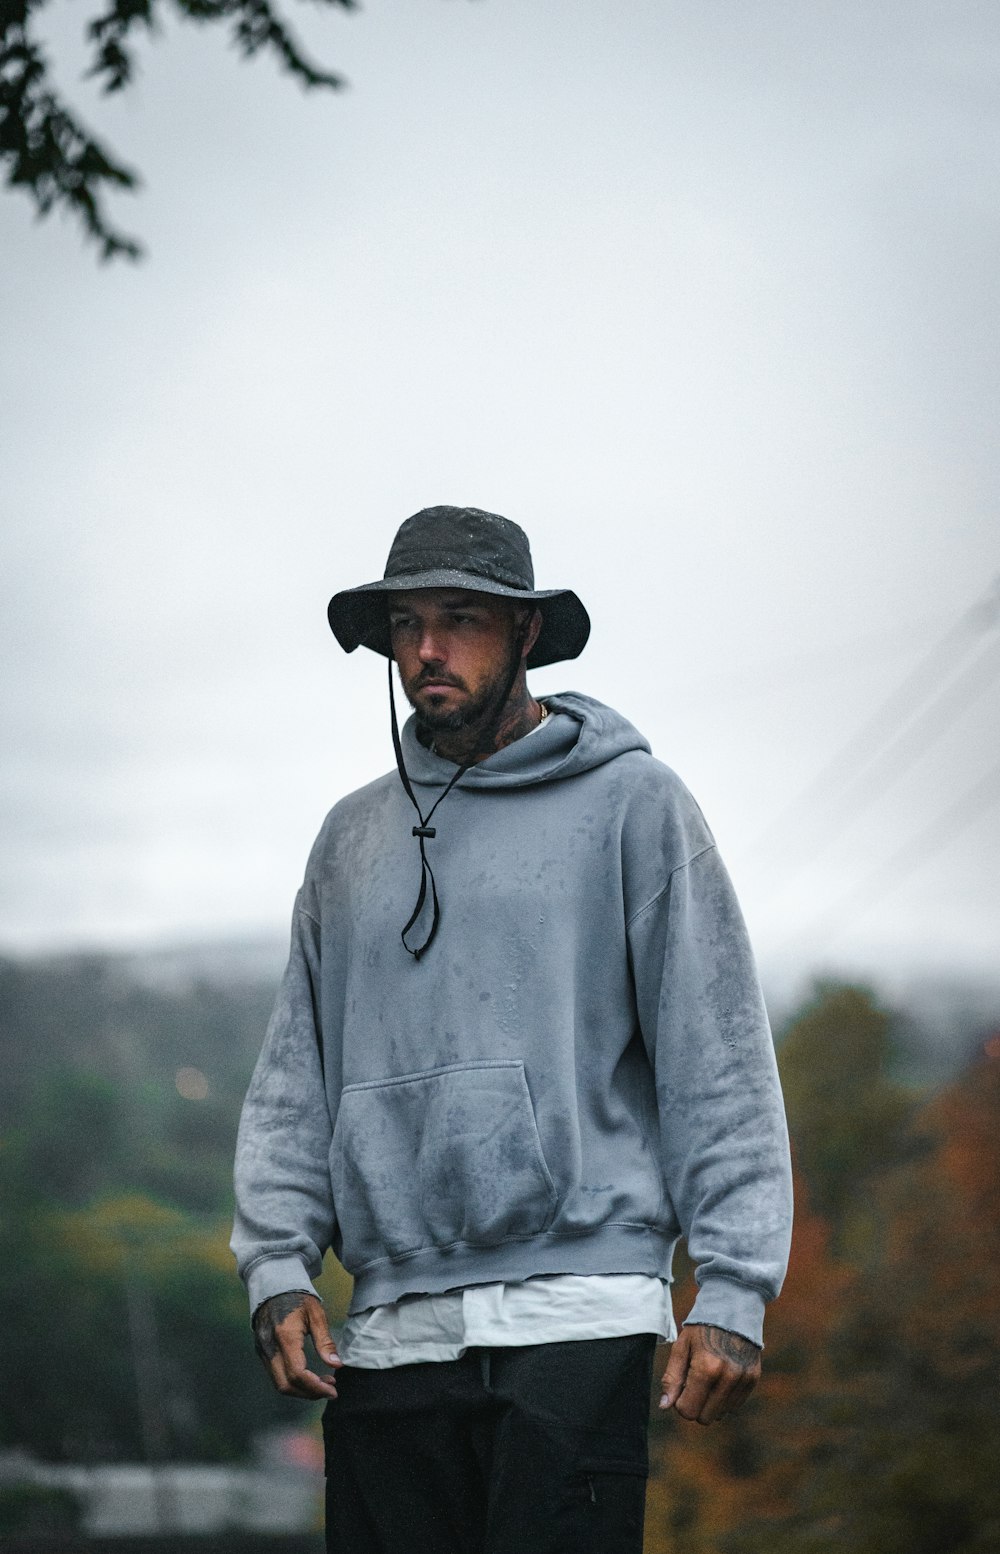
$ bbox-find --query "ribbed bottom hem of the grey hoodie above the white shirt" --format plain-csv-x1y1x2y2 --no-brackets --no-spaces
351,1223,677,1315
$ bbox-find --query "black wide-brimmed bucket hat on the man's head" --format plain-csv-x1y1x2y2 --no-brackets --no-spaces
326,507,590,668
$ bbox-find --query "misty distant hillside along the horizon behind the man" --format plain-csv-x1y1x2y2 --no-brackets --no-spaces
0,939,1000,1106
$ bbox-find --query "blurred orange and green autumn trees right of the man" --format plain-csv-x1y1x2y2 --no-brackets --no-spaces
646,985,1000,1554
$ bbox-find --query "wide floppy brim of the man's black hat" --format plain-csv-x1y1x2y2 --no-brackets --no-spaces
326,570,590,668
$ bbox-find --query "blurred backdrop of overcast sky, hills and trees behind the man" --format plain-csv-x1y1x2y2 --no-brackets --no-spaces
0,0,1000,1554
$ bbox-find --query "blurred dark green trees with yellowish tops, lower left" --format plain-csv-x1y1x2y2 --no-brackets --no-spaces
0,1192,345,1461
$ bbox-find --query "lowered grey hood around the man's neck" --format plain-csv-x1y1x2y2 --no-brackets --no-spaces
401,690,651,789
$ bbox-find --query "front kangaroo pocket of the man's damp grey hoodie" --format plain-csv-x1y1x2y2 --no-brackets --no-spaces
331,1058,556,1271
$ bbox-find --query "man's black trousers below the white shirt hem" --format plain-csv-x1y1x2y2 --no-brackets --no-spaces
323,1333,655,1554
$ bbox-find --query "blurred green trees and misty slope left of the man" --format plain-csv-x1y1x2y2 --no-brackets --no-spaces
0,956,355,1461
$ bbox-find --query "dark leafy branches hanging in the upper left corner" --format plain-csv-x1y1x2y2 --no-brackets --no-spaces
0,0,356,260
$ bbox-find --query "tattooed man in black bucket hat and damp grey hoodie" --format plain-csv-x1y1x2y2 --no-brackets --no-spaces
233,507,790,1554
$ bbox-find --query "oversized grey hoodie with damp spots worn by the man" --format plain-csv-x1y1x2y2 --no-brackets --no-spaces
233,693,792,1343
